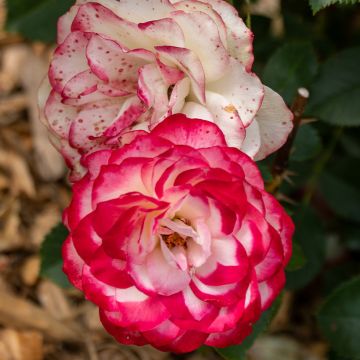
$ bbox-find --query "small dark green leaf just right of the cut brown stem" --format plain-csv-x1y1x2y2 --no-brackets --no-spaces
291,125,322,161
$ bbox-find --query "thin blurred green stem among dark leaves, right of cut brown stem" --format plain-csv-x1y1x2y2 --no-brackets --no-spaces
302,127,344,206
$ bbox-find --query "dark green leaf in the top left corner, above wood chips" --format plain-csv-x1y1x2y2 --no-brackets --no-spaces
6,0,75,42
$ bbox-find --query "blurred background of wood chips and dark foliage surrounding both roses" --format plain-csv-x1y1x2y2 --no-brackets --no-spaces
0,0,360,360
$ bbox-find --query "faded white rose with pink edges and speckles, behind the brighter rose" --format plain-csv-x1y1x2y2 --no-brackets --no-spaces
40,0,292,180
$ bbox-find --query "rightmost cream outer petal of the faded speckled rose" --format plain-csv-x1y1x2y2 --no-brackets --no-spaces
255,87,293,160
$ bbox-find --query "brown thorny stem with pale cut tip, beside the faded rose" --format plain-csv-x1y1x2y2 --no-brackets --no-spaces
267,88,309,193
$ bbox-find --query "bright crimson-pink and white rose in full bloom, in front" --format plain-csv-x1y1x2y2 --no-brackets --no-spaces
63,115,293,352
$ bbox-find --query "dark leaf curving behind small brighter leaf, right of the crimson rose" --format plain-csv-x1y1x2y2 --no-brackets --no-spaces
286,207,325,290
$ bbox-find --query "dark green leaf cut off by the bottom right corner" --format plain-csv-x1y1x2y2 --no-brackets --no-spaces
318,276,360,359
